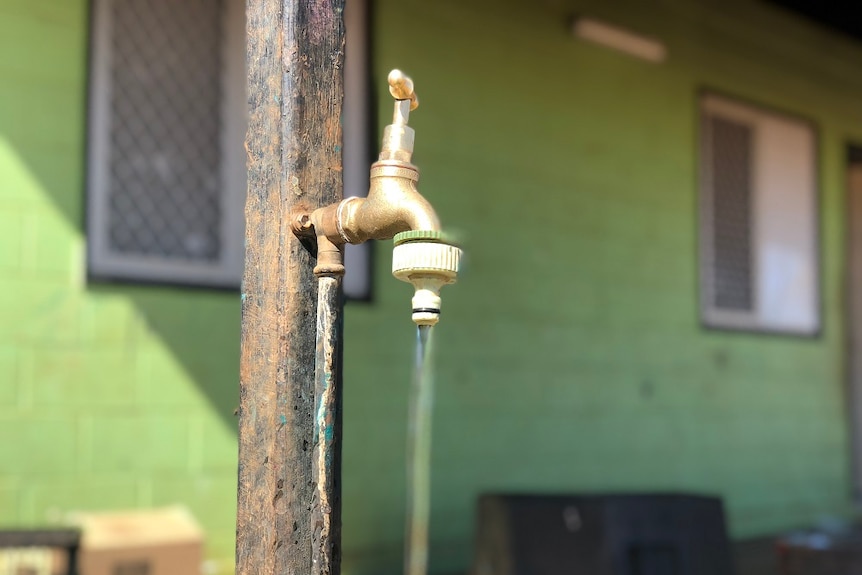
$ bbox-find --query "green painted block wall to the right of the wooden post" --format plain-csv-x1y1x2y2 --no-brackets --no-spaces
344,0,862,573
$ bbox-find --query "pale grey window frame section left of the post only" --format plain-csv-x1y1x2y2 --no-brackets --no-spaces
87,0,246,289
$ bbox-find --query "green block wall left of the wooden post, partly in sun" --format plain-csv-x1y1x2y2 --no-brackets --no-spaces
0,0,239,572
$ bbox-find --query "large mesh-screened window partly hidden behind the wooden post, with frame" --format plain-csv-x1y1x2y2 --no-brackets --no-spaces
88,0,370,298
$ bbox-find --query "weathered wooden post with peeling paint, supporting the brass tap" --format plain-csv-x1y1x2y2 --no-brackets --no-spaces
236,0,344,575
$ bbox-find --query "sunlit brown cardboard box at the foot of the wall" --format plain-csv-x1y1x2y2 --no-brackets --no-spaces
76,507,203,575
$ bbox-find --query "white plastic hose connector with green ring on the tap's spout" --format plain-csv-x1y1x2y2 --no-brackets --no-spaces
392,231,461,325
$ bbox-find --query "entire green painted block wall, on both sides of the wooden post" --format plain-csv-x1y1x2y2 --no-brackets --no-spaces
0,0,862,573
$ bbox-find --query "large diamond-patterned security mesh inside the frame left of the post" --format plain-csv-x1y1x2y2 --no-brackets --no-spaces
108,0,223,261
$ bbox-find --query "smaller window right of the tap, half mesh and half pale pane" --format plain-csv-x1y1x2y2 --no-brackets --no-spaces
700,94,820,335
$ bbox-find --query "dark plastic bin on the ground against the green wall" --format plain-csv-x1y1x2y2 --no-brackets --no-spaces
473,494,733,575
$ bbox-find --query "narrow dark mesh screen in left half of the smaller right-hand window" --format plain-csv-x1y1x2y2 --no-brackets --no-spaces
708,116,754,310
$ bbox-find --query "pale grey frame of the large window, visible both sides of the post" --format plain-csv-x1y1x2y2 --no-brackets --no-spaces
85,0,375,301
